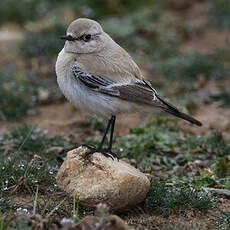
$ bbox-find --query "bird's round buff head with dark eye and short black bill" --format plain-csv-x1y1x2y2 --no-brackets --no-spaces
61,18,108,53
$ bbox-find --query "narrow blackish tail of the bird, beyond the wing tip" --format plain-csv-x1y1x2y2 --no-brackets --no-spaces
157,95,202,126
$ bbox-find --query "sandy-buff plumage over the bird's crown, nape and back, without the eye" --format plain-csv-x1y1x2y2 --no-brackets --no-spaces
56,19,143,82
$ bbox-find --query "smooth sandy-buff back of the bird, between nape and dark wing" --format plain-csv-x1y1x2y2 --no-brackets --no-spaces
76,35,143,83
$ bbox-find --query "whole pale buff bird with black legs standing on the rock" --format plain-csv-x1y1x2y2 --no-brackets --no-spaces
55,18,202,159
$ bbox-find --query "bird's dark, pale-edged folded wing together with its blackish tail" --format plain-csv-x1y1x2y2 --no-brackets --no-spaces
72,65,202,126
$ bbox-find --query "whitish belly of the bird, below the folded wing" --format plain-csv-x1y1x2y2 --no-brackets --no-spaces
57,74,134,117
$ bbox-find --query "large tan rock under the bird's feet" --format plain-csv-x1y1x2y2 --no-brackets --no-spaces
57,147,150,211
